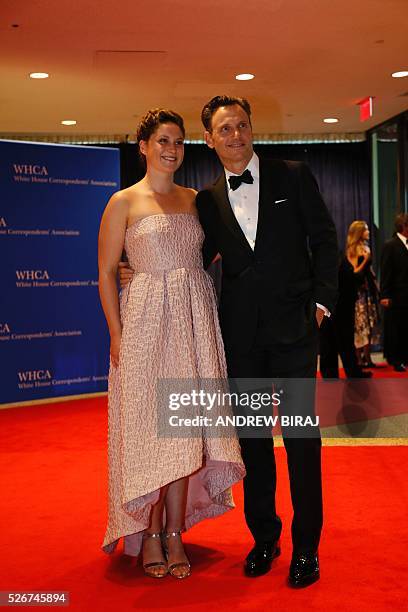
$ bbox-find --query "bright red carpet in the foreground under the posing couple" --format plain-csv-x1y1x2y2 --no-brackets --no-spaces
0,398,408,612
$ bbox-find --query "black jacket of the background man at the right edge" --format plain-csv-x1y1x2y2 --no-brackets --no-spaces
381,236,408,308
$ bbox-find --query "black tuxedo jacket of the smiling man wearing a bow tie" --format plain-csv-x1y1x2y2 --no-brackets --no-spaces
197,159,338,352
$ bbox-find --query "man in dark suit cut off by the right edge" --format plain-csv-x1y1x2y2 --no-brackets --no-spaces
381,213,408,372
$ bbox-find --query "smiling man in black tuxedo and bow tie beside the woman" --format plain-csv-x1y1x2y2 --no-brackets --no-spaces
197,96,338,586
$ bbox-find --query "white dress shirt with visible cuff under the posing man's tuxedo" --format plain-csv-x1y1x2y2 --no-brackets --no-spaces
224,153,330,317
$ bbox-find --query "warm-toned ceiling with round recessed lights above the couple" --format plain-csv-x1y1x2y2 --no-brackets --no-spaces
0,0,408,138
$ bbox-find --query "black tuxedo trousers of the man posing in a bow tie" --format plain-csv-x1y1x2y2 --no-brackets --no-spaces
226,325,323,553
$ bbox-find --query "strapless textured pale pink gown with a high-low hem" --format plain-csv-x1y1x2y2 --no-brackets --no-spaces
103,213,245,555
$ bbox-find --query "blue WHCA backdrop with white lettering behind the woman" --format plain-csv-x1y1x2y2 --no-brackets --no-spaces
0,141,120,407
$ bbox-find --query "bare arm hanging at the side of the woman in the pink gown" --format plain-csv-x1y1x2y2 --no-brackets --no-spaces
98,192,128,367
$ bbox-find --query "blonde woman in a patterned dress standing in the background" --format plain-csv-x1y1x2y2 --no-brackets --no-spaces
346,221,378,367
